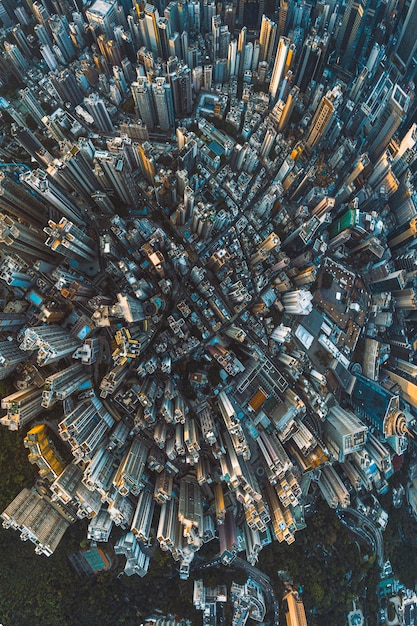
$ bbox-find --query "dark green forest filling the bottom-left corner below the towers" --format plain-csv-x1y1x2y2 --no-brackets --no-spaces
0,522,198,626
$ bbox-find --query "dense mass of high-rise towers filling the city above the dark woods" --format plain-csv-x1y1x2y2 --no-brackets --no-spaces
0,0,417,615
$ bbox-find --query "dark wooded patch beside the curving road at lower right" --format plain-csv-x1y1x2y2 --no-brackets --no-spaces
259,499,379,626
